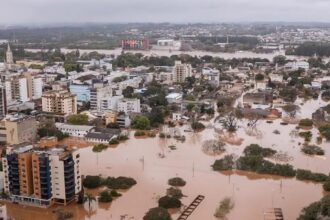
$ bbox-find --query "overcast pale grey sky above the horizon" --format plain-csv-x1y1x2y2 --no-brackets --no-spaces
0,0,330,24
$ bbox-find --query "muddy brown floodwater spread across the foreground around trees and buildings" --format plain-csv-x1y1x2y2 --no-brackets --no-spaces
6,98,330,220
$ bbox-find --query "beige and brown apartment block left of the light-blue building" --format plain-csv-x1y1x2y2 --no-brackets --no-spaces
42,90,77,115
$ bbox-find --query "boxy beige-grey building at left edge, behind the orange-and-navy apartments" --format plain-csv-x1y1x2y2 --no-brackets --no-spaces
5,115,38,144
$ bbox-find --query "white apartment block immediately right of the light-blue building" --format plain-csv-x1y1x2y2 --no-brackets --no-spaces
90,84,112,111
